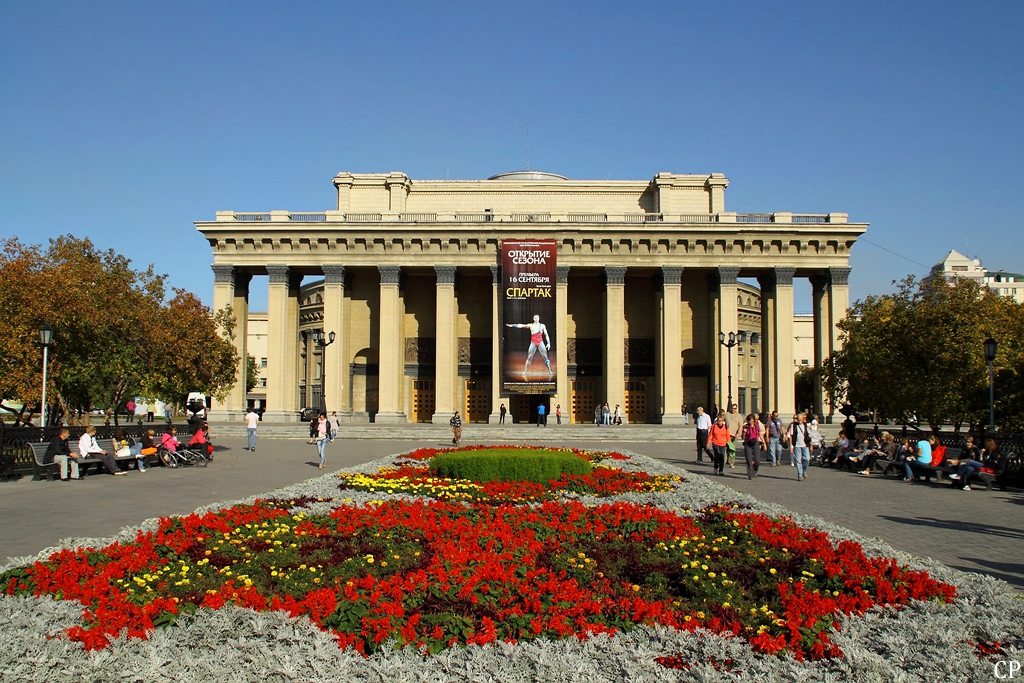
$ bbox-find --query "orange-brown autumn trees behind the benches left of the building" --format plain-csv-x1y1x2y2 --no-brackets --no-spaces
0,236,237,422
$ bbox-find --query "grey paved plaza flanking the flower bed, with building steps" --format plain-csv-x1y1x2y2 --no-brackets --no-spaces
0,425,1024,590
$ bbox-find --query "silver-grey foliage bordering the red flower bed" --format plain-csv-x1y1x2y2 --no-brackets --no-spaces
0,453,1024,683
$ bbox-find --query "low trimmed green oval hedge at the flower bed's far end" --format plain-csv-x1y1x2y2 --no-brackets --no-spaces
430,449,592,483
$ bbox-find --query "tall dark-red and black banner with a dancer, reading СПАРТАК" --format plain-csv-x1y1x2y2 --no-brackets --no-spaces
502,240,562,393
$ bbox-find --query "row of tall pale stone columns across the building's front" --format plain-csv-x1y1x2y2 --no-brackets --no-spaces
205,264,850,424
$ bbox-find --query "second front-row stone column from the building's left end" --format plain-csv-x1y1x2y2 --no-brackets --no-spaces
263,265,299,422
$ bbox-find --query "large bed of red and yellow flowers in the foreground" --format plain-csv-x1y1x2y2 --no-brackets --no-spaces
0,446,1020,680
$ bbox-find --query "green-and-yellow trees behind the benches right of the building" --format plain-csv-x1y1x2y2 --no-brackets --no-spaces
823,278,1024,430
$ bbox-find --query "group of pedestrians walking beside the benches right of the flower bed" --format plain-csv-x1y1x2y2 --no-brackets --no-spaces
696,403,821,481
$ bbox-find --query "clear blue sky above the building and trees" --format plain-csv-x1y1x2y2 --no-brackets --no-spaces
0,0,1024,310
